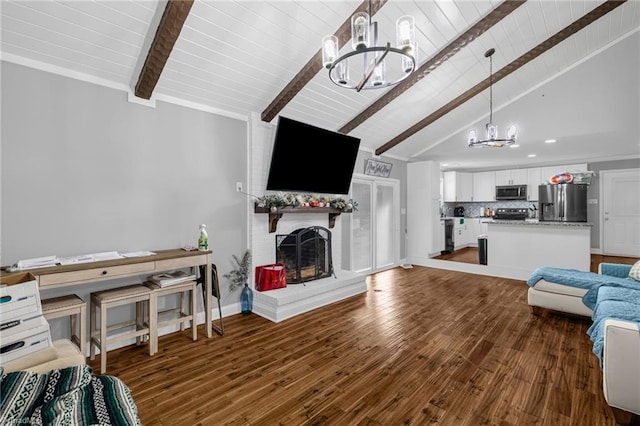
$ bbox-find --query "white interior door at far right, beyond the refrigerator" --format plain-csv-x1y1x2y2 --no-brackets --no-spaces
600,169,640,257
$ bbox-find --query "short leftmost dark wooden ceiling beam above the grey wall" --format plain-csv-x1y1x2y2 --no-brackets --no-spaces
135,0,194,99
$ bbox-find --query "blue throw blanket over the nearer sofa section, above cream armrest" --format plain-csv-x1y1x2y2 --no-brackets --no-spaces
587,284,640,367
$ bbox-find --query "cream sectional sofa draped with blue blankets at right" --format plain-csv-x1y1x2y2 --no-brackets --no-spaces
527,262,640,424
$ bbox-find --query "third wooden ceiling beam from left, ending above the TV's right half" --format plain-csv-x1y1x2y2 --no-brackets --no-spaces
338,0,526,133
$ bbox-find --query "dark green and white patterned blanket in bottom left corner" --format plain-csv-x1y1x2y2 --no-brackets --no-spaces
0,365,140,426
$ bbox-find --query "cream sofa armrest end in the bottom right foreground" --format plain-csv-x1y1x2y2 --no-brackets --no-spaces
602,319,640,414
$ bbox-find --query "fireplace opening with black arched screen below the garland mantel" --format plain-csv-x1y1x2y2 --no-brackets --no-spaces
276,226,333,284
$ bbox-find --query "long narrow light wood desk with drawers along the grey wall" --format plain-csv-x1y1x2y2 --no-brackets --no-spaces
8,249,213,337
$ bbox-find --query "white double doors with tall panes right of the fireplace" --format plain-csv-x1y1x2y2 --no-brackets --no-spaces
351,177,400,272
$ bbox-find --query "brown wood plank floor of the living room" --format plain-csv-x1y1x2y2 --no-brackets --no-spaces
86,267,636,426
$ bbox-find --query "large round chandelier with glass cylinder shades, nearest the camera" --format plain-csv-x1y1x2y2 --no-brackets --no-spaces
322,0,418,92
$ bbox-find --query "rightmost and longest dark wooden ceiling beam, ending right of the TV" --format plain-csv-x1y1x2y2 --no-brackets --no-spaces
375,0,627,155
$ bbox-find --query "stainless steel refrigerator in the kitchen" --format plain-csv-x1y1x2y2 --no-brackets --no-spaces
538,183,589,222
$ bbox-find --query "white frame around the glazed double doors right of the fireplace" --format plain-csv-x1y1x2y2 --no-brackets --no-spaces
349,173,400,273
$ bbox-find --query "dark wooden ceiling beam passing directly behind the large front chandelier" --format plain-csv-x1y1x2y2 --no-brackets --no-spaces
262,0,387,122
